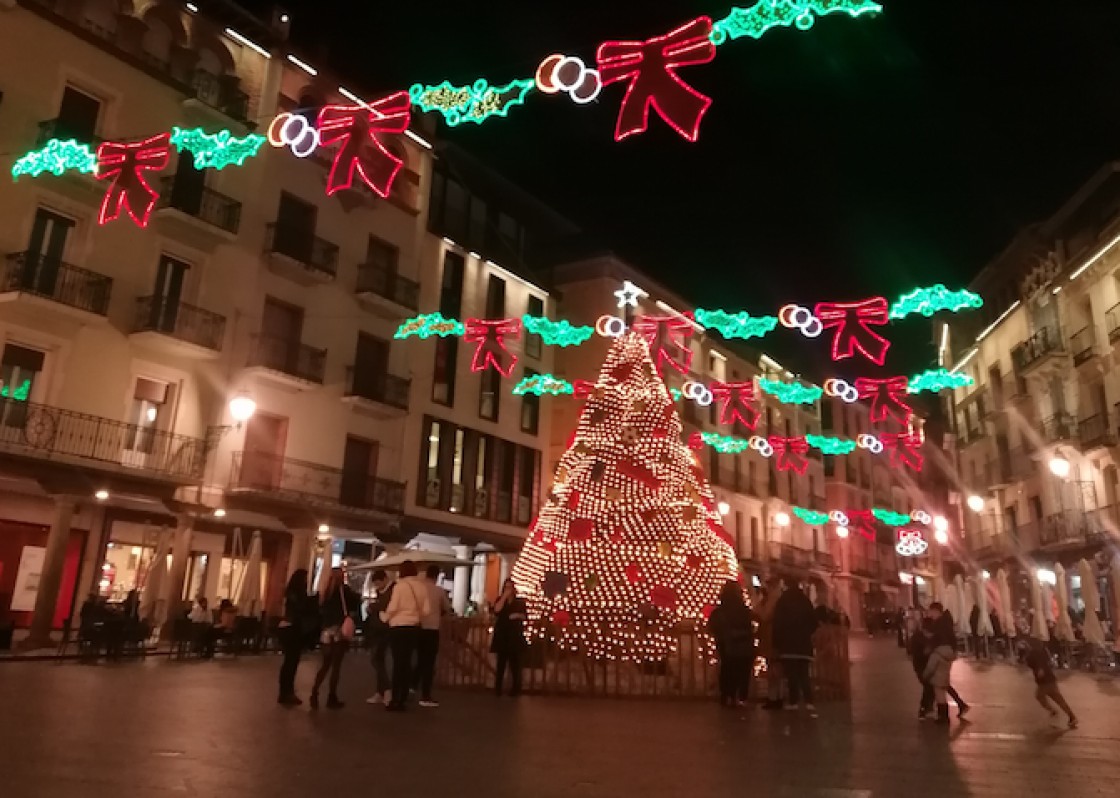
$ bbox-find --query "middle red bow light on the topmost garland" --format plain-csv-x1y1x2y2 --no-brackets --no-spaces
319,92,411,197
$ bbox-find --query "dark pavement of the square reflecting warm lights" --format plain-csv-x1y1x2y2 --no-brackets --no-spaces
0,639,1120,798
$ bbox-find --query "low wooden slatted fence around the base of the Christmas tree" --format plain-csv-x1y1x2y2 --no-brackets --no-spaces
436,618,850,700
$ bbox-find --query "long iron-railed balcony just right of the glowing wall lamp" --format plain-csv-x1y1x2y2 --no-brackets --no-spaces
230,452,404,513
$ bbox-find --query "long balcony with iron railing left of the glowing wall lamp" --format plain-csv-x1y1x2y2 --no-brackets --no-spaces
0,398,206,483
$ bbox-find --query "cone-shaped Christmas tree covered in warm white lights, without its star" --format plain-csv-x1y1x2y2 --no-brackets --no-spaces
513,334,738,662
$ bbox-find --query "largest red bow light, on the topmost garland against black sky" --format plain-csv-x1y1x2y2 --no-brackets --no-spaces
596,17,716,141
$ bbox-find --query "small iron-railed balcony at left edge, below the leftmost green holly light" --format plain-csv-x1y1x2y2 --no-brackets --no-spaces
0,252,113,322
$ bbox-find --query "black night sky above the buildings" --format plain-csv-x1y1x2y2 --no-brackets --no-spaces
244,0,1120,365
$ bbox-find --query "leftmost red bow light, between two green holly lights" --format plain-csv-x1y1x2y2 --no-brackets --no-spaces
97,133,171,228
